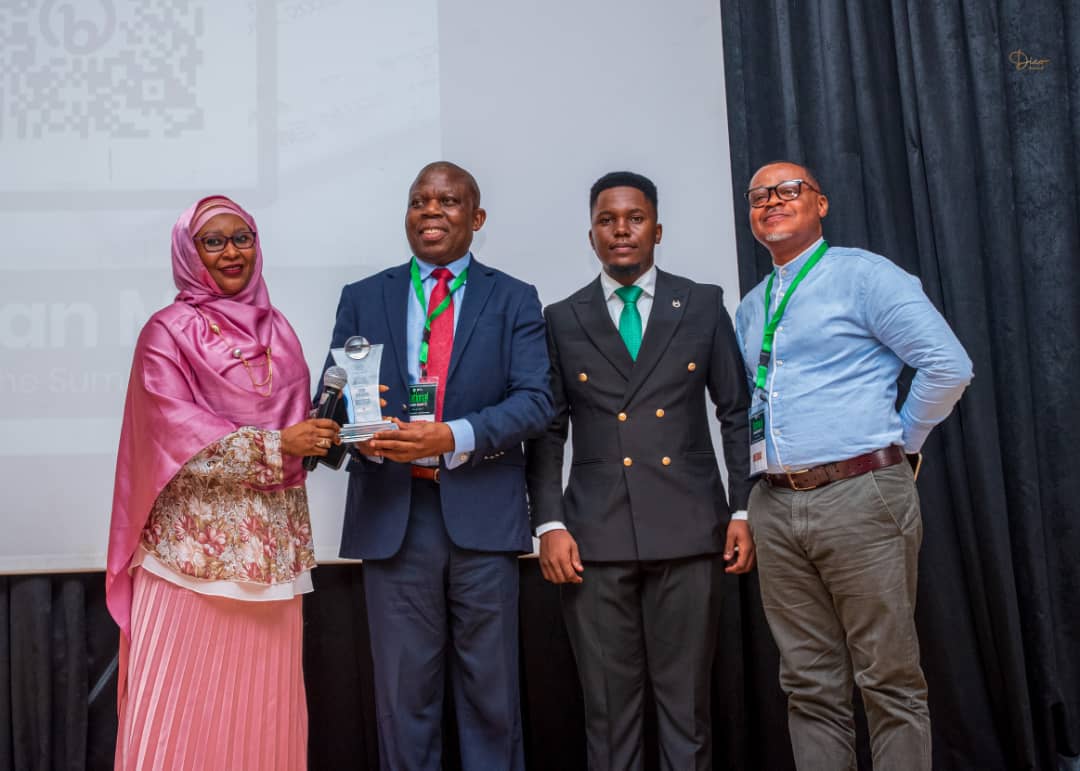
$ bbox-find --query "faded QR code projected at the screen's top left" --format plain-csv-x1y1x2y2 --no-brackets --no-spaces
0,0,205,141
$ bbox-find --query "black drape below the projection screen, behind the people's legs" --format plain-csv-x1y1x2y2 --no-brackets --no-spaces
0,559,777,771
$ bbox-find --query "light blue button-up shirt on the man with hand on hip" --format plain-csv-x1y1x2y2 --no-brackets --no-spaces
735,240,972,473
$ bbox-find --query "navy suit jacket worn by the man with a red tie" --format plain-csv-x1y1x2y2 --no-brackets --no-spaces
327,256,554,559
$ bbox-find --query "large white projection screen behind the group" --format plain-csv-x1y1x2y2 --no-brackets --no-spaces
0,0,741,572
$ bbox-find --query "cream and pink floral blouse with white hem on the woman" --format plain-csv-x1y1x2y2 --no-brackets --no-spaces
136,427,315,599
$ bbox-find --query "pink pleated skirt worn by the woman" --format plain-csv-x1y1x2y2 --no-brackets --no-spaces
116,568,308,771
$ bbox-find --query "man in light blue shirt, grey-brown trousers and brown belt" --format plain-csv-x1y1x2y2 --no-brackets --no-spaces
735,162,972,771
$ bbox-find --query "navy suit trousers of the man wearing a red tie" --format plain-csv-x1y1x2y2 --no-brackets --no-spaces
364,479,525,771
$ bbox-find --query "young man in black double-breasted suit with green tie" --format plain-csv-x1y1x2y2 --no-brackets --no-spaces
527,172,754,769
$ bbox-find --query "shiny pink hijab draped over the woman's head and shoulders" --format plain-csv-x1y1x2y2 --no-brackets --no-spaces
105,195,310,638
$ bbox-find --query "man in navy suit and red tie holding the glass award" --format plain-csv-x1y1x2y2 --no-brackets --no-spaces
332,162,553,771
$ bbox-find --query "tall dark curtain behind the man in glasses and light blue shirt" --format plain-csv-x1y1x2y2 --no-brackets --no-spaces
720,0,1080,770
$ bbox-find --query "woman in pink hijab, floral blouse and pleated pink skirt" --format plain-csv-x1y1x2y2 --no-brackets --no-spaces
106,195,338,771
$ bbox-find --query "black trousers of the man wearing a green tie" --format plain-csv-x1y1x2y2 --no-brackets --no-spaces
562,554,724,771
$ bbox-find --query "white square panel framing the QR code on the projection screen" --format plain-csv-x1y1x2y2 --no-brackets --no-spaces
0,0,276,209
